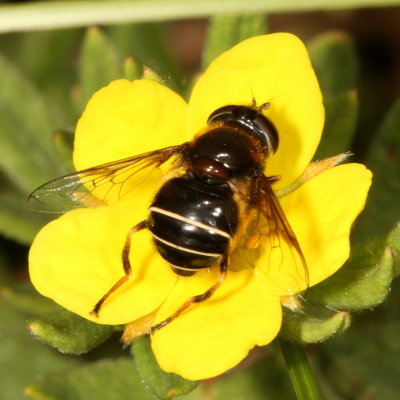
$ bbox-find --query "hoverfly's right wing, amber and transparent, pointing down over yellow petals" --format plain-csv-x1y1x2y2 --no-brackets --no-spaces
252,175,309,295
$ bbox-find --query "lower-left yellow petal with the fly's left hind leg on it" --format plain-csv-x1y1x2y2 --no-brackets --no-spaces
29,202,176,324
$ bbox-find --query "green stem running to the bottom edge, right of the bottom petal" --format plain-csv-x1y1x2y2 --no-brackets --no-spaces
279,338,321,400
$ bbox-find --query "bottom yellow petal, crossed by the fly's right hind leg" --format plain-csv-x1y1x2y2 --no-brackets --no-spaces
152,269,282,380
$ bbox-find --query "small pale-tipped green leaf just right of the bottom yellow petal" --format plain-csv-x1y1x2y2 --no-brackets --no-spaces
280,304,350,343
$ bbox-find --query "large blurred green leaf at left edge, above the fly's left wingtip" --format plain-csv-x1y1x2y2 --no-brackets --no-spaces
0,55,64,193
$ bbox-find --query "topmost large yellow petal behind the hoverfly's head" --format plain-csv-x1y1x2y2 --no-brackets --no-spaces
187,33,324,189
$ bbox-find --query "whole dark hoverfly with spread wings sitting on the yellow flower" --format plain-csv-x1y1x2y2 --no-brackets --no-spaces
28,100,308,333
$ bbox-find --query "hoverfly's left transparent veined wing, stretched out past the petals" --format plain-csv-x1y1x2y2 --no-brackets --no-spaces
28,144,186,213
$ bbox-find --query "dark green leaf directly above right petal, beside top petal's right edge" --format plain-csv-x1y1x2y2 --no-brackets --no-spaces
314,91,358,160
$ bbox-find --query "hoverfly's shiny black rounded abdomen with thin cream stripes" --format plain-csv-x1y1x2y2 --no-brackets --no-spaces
149,173,238,274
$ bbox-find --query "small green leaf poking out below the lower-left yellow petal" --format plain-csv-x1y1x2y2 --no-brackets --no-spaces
28,307,114,354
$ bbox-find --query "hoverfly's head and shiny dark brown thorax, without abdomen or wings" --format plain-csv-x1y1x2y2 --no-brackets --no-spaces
186,106,279,185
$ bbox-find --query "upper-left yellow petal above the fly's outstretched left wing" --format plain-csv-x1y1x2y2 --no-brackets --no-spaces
74,79,186,170
